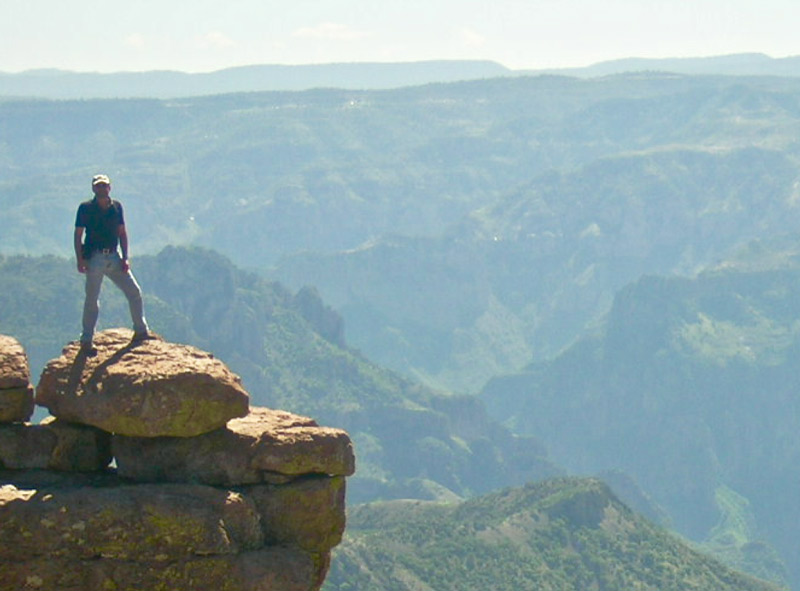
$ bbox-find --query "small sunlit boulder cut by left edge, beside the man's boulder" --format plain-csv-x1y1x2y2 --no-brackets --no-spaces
0,335,34,423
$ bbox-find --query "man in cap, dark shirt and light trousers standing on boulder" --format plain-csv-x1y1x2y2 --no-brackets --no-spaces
73,174,150,356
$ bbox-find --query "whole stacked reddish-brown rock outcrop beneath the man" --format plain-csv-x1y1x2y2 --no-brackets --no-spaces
0,330,355,591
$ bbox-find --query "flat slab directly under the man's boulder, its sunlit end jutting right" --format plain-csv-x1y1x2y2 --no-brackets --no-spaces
112,407,355,486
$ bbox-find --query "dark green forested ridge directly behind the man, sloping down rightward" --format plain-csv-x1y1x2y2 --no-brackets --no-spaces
0,247,560,502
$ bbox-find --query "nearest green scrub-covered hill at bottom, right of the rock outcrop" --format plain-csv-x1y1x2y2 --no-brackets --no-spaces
323,480,778,591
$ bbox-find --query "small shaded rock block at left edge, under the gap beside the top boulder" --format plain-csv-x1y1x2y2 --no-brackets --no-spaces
0,417,111,472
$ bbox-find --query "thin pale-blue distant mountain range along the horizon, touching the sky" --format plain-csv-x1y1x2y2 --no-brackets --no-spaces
0,53,800,99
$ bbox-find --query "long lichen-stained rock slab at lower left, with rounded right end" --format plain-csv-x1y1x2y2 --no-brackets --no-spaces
0,483,264,562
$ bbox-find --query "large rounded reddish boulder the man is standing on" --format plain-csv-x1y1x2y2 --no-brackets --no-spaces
36,329,249,437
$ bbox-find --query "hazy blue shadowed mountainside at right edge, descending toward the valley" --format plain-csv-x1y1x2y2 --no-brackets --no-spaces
482,242,800,585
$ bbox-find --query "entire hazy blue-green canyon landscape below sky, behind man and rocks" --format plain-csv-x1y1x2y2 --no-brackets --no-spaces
0,55,800,591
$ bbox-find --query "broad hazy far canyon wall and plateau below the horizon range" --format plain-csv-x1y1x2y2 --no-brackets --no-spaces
0,73,800,392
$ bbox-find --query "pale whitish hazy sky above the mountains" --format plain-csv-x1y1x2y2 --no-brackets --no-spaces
0,0,800,72
